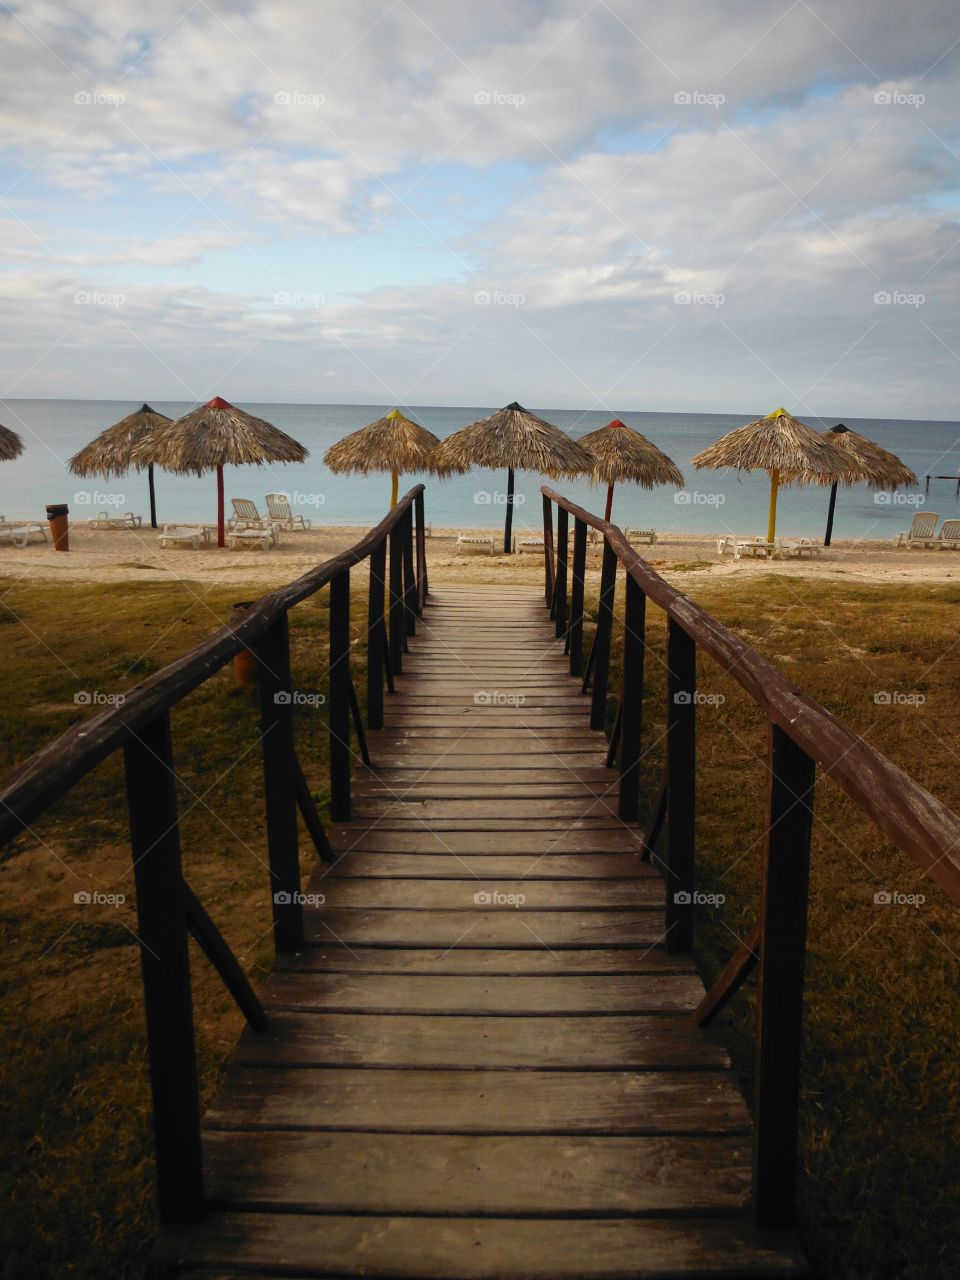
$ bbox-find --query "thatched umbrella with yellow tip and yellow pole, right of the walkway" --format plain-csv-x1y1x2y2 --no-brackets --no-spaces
692,408,860,543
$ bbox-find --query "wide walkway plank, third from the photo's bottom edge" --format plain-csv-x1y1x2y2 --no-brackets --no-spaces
204,1066,750,1136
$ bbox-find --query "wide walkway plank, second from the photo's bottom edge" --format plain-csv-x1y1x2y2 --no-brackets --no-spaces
204,1136,750,1216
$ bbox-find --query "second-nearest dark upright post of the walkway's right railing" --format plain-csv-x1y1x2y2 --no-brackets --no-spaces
667,618,696,952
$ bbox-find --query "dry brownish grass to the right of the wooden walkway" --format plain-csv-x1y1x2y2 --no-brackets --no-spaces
604,575,960,1280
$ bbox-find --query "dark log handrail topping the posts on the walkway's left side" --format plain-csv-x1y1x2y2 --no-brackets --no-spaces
0,484,424,844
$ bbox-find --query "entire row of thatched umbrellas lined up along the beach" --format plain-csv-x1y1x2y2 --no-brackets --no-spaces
56,396,918,554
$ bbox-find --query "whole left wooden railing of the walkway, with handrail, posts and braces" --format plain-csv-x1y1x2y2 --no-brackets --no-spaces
0,485,428,1220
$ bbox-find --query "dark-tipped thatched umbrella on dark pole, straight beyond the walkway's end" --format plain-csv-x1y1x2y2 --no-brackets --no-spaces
430,401,594,556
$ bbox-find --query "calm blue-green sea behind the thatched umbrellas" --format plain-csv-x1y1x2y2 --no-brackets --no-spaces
0,399,960,538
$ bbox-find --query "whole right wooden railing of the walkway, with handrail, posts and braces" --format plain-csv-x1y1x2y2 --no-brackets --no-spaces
541,486,960,1228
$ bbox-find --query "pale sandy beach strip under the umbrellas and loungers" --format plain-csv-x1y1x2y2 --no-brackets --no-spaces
0,522,960,594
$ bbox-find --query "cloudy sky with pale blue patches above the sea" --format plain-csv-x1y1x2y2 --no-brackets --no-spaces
0,0,960,420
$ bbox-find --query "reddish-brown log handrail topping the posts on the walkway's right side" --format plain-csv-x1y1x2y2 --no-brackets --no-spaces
541,485,960,902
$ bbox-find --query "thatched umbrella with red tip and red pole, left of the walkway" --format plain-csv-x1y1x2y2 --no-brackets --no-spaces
131,396,307,547
